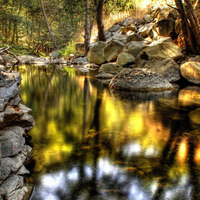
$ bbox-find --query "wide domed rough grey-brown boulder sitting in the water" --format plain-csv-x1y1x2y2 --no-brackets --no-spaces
109,68,173,91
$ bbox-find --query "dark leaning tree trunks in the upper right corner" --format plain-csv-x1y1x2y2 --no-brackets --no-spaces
175,0,200,54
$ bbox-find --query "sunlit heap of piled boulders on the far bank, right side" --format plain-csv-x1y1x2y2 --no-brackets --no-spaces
77,7,200,91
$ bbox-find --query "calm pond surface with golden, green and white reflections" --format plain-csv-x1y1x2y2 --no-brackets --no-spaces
20,66,200,200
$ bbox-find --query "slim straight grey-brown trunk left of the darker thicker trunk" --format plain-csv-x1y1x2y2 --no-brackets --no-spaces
85,0,90,55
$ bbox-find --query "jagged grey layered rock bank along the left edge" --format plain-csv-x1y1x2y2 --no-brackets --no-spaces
0,66,35,200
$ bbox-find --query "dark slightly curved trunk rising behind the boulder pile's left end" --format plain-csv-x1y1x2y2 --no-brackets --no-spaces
97,0,106,41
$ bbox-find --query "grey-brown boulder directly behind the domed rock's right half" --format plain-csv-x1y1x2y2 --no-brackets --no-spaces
144,58,181,82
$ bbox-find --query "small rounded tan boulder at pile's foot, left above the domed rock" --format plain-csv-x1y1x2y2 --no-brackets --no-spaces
116,52,135,67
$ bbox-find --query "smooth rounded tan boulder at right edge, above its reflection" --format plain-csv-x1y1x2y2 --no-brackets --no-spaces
180,62,200,84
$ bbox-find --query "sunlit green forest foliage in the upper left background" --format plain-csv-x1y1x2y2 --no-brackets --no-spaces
0,0,134,56
